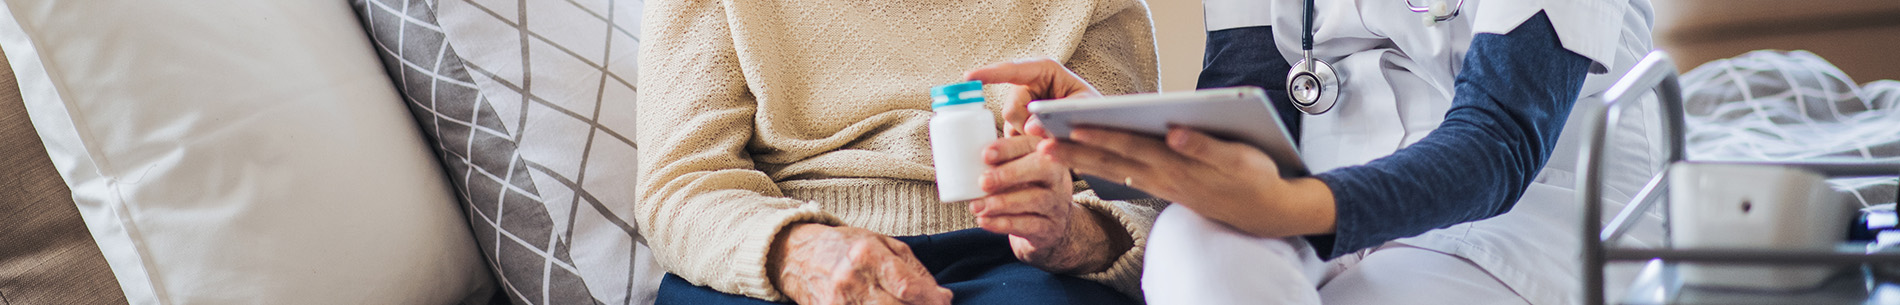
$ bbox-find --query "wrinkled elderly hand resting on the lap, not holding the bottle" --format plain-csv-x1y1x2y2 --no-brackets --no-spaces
766,224,952,305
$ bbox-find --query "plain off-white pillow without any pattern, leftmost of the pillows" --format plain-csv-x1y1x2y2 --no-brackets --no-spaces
0,0,494,305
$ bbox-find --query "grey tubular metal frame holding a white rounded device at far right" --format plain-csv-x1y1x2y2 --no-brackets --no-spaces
1577,51,1900,305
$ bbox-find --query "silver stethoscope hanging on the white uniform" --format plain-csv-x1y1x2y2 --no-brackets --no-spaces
1286,0,1465,116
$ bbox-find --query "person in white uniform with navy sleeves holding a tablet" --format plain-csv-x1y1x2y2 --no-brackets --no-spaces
965,0,1651,305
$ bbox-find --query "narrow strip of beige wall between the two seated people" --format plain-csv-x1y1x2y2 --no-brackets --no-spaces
1148,0,1207,91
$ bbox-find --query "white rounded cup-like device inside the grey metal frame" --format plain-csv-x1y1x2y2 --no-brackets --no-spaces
1668,163,1854,292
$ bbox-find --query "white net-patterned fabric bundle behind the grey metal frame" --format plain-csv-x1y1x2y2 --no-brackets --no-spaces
1682,51,1900,206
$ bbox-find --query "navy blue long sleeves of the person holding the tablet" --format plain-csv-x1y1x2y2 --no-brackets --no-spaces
1199,13,1590,258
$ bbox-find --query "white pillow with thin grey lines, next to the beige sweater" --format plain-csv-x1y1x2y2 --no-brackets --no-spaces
435,0,665,305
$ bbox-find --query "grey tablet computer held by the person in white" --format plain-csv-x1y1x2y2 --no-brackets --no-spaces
1030,87,1307,201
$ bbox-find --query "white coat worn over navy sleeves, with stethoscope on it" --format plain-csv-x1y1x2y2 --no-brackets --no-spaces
1205,0,1651,305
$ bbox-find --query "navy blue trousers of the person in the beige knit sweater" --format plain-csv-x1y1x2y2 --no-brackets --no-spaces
656,229,1136,305
